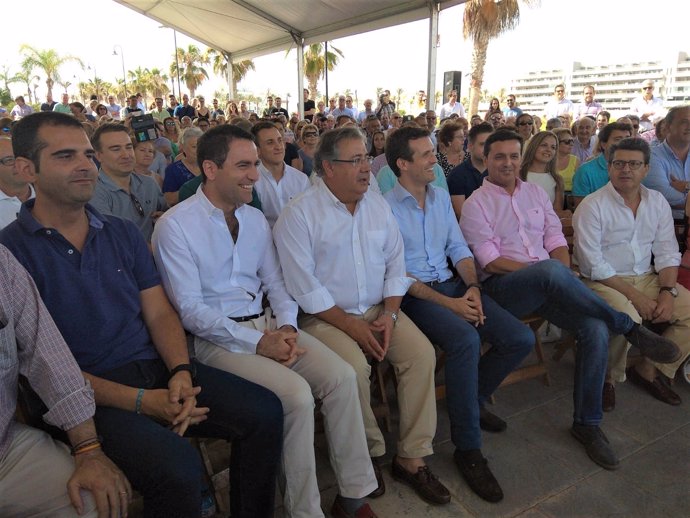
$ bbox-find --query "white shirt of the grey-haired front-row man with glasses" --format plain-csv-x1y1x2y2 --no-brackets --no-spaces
273,181,412,315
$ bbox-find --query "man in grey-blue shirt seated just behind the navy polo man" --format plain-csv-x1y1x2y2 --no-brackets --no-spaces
90,124,168,242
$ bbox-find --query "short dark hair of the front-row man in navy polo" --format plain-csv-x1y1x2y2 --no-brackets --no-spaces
12,112,84,172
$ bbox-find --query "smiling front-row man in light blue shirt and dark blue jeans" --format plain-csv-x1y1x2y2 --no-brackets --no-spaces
384,127,534,502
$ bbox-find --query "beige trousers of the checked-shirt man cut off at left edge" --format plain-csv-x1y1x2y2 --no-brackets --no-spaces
0,422,98,518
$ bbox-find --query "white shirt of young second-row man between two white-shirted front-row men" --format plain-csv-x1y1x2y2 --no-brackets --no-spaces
254,164,309,228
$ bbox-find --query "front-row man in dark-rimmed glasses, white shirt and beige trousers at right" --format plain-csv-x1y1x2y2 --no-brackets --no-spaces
573,138,690,410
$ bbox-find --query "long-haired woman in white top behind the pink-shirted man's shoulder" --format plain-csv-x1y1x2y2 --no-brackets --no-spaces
520,131,564,212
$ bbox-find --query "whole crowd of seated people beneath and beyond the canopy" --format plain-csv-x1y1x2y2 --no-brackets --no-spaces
0,82,690,518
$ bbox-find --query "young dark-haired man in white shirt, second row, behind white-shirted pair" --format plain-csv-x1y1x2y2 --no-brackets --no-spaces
252,121,309,228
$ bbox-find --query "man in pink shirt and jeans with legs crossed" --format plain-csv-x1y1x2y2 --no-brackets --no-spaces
460,129,680,476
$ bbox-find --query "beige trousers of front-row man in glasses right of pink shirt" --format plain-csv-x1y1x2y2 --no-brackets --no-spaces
585,273,690,381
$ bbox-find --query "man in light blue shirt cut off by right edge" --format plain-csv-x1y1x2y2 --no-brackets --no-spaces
642,105,690,219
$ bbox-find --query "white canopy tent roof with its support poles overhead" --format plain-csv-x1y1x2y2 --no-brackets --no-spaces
115,0,466,114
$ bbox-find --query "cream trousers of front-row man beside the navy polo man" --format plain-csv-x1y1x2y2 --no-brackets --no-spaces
195,310,377,518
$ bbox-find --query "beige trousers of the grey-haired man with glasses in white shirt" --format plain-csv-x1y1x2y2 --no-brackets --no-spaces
300,304,436,458
